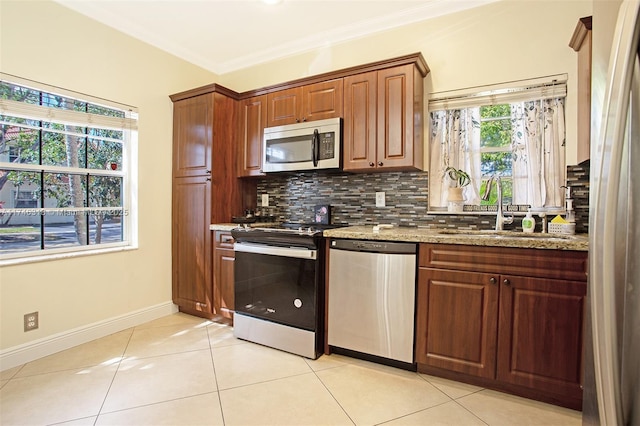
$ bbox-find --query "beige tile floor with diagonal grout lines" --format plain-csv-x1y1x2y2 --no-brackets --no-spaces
0,314,582,426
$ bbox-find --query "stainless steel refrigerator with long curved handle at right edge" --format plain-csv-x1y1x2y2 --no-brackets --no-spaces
583,0,640,425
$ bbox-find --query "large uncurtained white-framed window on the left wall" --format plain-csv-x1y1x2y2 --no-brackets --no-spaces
0,74,137,261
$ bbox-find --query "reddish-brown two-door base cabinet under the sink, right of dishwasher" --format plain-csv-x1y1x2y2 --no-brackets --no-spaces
416,244,587,410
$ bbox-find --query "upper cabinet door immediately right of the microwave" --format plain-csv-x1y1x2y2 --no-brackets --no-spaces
342,71,378,171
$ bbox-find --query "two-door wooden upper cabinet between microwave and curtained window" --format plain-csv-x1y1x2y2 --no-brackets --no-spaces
343,64,424,172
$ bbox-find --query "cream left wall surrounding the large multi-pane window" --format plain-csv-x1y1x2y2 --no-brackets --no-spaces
0,0,216,360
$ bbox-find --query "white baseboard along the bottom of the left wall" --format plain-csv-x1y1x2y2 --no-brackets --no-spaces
0,302,178,371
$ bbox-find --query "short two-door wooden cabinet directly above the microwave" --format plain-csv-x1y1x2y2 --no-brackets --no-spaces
267,78,343,127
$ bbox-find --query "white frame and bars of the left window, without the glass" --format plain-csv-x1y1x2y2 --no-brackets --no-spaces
0,73,138,266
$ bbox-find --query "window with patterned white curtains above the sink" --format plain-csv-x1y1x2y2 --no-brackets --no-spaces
429,76,566,211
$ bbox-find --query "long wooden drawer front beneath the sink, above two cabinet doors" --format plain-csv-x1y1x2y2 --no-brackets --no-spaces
419,244,588,281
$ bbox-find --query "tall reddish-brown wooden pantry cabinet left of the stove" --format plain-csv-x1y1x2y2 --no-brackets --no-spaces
170,84,242,318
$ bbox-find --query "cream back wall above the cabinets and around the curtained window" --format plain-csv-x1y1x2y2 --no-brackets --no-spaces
220,0,591,164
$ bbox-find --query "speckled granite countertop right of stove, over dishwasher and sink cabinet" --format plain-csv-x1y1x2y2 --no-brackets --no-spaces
323,226,589,251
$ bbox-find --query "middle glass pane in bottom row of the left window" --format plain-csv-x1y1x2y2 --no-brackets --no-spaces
44,211,87,249
